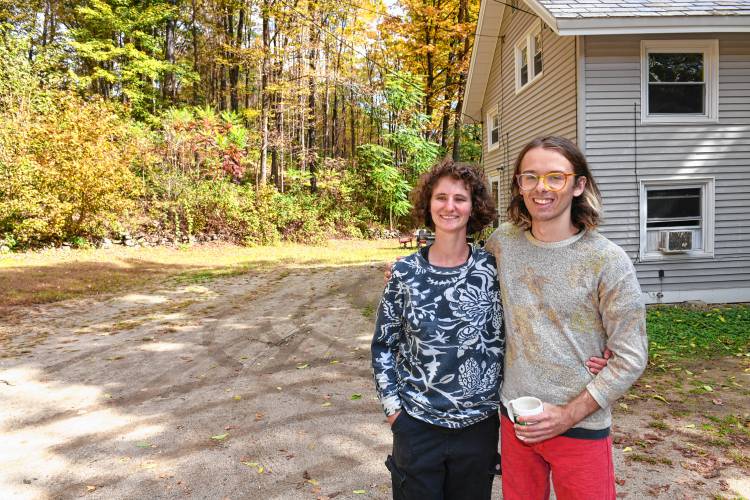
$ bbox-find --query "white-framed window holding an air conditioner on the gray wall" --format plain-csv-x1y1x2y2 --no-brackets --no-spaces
640,178,714,260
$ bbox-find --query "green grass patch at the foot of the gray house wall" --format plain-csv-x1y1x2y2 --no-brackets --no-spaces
646,305,750,363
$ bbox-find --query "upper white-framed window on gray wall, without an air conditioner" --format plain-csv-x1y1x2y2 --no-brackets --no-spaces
641,40,719,123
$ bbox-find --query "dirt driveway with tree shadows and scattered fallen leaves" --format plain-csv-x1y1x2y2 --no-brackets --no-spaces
0,264,750,499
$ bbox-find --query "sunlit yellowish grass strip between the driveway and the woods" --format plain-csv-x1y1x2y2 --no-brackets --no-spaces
0,240,414,306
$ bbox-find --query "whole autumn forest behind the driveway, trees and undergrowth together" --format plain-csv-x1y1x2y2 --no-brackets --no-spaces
0,0,481,249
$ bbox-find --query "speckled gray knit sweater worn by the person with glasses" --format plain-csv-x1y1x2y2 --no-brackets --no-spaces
485,223,648,429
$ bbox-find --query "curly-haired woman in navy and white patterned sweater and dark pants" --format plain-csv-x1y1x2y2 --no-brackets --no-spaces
372,160,612,500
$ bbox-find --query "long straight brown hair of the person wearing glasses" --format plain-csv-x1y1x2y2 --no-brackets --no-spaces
508,135,602,229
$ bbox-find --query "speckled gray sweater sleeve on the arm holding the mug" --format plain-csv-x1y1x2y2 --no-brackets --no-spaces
586,249,648,408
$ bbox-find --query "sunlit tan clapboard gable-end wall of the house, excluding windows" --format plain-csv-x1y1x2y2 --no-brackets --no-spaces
481,4,577,220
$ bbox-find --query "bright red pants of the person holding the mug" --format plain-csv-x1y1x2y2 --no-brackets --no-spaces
500,416,615,500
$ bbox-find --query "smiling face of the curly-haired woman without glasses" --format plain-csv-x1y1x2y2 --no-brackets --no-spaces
430,177,472,235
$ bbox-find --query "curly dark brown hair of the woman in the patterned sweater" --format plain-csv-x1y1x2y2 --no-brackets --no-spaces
412,159,497,234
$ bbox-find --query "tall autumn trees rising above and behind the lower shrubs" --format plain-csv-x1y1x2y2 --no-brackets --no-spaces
0,0,478,184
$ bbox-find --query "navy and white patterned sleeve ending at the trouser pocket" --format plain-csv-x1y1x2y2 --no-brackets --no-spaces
371,270,406,416
